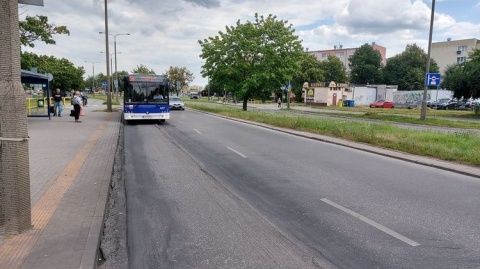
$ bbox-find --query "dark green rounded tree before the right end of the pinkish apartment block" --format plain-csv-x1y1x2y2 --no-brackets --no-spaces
348,44,382,84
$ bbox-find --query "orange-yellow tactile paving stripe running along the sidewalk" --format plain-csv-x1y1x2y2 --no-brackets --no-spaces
0,116,106,269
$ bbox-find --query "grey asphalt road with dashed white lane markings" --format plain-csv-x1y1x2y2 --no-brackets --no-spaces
124,111,480,268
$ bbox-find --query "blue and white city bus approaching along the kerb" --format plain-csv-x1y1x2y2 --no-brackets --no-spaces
122,74,171,122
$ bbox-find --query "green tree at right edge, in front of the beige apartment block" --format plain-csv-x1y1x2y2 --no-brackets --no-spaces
440,49,480,98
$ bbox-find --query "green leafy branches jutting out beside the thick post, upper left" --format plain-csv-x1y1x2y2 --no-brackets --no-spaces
20,15,70,48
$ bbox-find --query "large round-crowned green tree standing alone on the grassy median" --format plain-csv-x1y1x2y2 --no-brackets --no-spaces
198,14,303,110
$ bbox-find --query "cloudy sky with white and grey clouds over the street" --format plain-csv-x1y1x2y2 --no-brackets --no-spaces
19,0,480,86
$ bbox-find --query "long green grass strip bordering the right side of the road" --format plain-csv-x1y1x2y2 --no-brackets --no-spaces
188,102,480,166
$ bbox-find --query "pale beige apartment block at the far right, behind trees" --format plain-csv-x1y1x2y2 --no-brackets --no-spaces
430,38,480,74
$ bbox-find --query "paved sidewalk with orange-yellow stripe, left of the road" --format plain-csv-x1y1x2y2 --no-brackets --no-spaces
0,99,121,269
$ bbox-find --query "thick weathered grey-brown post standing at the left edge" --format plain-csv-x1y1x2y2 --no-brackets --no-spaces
0,0,31,234
